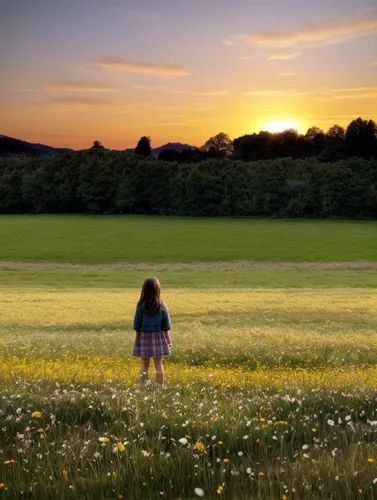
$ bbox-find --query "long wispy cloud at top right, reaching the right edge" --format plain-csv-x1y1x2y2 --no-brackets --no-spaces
228,10,377,48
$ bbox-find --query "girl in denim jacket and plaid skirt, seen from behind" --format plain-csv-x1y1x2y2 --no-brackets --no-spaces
132,278,173,384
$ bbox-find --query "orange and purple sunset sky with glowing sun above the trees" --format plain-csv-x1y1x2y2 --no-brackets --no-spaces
0,0,377,149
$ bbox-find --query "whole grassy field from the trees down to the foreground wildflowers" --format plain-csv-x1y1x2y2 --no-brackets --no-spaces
0,217,377,500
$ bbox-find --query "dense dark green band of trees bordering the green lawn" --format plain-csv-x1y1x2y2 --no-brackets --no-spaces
0,153,377,218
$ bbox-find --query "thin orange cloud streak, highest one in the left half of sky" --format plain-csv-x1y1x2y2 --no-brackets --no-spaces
95,58,190,76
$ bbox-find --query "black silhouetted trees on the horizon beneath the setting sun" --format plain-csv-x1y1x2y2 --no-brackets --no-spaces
129,118,377,163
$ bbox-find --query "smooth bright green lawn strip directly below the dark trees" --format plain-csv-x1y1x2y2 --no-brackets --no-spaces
0,215,377,264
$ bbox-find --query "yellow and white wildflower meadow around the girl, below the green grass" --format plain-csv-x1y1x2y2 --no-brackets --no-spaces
0,284,377,500
